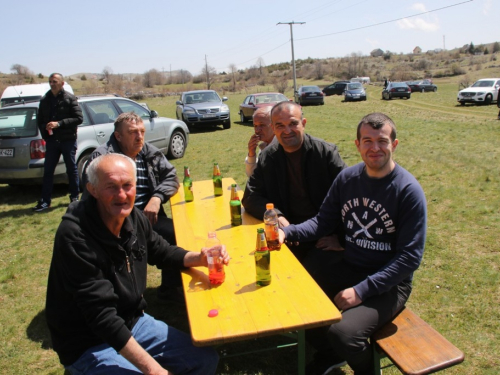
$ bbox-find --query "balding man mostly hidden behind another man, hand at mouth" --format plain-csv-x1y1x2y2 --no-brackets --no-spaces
245,105,274,177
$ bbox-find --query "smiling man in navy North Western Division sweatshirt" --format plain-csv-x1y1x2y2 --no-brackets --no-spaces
280,113,427,375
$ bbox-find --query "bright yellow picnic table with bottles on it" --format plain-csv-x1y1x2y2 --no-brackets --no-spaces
170,178,341,374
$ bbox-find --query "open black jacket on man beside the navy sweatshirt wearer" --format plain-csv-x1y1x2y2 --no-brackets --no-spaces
241,134,347,224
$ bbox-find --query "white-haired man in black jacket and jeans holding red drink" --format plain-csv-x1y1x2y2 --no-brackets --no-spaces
45,154,225,375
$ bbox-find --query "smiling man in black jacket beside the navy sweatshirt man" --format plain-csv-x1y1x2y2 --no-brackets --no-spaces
242,102,346,262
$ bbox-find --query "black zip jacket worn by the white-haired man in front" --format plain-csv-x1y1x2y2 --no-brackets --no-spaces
45,196,186,366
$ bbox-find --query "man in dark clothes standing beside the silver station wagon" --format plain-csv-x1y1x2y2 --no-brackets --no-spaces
33,73,83,212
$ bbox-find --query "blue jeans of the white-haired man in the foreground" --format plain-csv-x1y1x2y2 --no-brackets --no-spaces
66,314,219,375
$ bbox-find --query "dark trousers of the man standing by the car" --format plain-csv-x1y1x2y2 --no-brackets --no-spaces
42,139,80,204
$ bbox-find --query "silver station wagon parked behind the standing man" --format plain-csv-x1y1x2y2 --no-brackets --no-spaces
0,95,189,185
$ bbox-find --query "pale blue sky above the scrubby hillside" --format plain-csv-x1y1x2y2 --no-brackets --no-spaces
0,0,500,75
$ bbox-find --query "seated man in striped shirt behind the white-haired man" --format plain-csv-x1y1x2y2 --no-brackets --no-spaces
82,112,184,303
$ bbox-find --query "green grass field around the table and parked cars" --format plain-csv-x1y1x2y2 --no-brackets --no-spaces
0,75,500,375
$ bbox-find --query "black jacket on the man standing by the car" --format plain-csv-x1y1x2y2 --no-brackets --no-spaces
37,89,83,141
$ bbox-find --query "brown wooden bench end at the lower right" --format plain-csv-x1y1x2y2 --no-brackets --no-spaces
372,307,464,375
